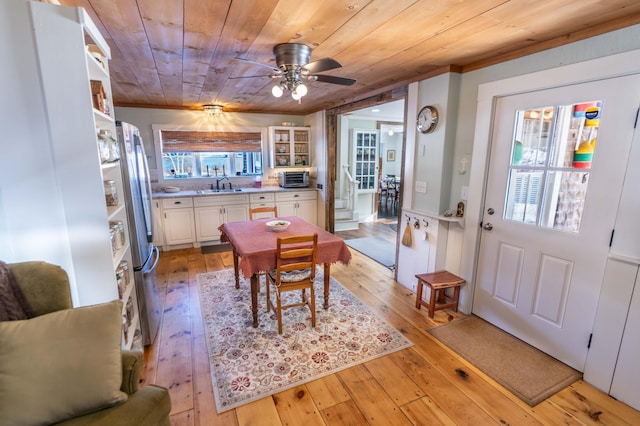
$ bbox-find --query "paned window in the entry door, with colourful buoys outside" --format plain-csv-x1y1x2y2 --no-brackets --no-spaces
504,101,602,232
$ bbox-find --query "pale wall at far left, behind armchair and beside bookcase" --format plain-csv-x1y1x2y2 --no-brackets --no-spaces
0,1,77,292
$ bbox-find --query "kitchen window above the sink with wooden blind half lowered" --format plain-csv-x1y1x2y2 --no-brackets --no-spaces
159,130,263,179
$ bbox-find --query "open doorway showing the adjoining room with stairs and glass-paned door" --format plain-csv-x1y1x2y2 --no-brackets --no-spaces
333,98,405,270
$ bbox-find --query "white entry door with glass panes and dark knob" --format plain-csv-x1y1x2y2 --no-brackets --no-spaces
473,76,640,371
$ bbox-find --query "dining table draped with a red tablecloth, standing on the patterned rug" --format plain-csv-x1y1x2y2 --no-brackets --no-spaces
218,216,351,327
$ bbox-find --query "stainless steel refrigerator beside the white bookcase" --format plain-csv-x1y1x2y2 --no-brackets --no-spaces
116,121,162,345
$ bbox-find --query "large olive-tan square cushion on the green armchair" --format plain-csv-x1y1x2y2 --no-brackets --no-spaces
0,301,127,426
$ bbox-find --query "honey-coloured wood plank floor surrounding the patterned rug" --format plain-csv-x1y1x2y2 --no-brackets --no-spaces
143,238,640,426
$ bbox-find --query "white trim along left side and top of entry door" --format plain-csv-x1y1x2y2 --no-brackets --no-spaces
460,49,640,320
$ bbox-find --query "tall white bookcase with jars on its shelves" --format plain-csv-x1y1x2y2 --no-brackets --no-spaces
29,2,141,348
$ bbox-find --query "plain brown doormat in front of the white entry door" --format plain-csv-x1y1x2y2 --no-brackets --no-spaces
428,315,582,407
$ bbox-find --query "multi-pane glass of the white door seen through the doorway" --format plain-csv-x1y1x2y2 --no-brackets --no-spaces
352,129,378,193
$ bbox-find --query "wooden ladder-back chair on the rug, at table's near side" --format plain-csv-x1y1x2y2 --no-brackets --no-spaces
267,234,318,334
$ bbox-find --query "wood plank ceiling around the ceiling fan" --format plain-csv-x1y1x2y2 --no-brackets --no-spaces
59,0,640,114
